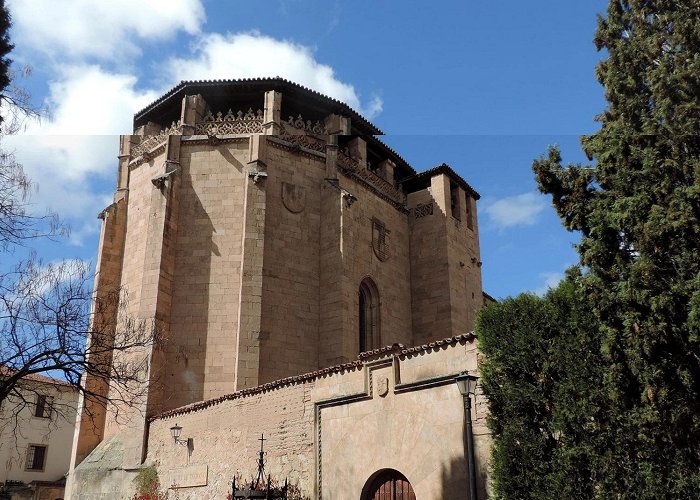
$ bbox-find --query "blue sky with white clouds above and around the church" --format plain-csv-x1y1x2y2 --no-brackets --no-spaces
3,0,607,297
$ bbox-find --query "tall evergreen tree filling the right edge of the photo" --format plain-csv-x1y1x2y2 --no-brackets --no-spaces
534,0,700,498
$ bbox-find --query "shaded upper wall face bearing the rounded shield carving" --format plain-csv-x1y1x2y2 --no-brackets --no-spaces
260,139,326,383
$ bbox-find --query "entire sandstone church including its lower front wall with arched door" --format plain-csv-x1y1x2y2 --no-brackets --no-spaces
66,78,490,500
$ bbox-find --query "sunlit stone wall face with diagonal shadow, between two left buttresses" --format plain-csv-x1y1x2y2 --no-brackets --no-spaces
164,138,249,409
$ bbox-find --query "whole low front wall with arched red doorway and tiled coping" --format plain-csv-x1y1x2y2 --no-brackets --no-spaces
139,337,489,500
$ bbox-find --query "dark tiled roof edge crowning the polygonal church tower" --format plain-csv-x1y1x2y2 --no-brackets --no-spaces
134,76,383,135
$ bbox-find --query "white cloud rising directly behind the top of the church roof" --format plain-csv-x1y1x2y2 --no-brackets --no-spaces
167,32,382,118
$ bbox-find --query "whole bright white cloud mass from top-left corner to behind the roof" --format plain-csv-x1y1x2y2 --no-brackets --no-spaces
2,17,382,244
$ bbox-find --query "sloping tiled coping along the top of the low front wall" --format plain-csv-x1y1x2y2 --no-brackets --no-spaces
150,332,476,421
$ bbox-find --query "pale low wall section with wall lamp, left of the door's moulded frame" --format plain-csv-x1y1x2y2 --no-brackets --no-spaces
147,381,314,500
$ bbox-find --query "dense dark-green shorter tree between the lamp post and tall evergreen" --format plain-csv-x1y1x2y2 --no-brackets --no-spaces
477,275,603,499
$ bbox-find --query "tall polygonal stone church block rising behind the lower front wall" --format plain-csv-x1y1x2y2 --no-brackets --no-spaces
72,78,483,484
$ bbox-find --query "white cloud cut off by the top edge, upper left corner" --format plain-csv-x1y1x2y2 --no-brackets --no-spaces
8,0,205,59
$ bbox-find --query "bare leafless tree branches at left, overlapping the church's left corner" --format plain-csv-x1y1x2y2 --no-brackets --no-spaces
0,258,160,426
